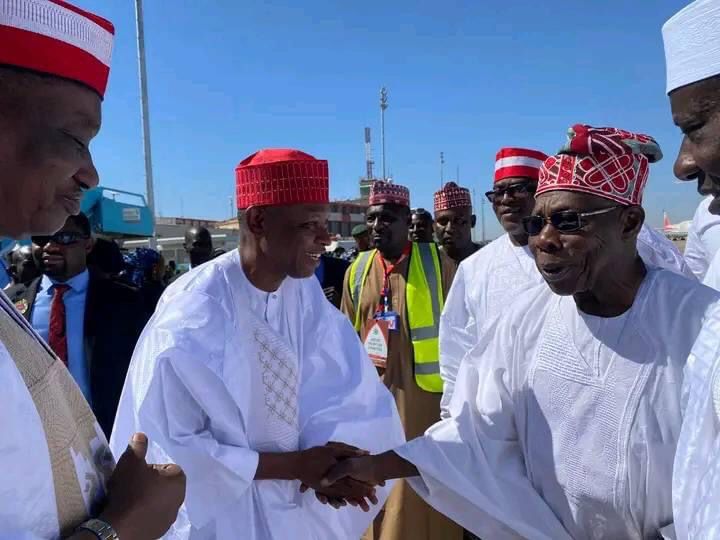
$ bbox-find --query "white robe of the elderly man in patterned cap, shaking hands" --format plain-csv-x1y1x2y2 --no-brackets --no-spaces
396,269,720,540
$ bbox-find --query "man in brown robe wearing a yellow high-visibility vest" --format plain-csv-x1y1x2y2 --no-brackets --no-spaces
341,181,462,540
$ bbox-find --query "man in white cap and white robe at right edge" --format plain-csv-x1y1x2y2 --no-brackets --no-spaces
662,0,720,539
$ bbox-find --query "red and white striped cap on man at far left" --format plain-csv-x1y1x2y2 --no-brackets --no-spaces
0,0,115,97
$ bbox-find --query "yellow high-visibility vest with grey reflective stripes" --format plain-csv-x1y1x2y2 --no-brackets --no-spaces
348,243,444,393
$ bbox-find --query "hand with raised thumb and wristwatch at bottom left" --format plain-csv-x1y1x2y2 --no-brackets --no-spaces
98,433,185,540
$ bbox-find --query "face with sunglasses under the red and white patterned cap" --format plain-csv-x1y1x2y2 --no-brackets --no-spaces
529,191,642,295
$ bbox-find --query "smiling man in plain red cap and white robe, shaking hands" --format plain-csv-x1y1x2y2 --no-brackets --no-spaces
111,149,404,540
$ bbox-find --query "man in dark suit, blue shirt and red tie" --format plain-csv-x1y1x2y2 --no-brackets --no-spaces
6,214,149,437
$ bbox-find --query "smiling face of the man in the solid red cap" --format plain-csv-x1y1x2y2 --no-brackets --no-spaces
260,204,331,278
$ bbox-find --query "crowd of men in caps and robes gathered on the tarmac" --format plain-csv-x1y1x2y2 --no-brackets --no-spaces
0,0,720,540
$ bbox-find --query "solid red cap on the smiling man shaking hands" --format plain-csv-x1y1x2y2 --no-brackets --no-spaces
235,149,330,210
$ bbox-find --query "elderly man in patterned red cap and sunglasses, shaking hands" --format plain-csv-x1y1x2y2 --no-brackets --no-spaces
325,125,720,540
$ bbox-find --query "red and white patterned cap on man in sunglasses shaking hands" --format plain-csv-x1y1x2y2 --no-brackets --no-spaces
535,124,662,205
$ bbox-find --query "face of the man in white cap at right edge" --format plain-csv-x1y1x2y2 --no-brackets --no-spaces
670,77,720,214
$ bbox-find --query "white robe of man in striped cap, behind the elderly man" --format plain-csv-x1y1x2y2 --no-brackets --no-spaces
440,225,694,418
